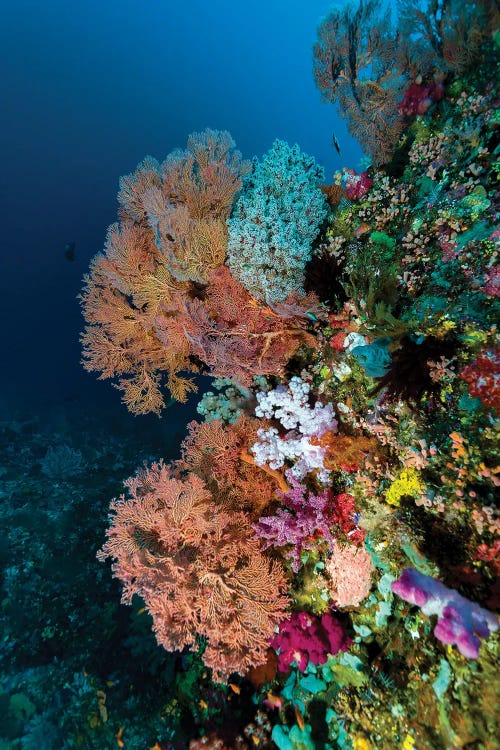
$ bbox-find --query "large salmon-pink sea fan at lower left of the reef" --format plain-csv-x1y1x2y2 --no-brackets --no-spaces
98,463,288,681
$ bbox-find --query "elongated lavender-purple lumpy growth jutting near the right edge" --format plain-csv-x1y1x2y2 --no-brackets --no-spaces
392,568,498,659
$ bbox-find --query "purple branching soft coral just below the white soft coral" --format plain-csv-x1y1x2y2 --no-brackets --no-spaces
253,471,335,573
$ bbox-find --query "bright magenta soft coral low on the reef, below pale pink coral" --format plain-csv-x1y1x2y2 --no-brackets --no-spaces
270,612,352,672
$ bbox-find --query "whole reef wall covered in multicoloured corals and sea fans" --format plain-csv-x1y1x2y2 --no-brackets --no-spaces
75,0,500,750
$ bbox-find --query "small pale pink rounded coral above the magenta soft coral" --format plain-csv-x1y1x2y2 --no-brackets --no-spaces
325,544,375,609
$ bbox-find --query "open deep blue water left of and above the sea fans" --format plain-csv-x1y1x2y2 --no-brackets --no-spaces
0,0,361,432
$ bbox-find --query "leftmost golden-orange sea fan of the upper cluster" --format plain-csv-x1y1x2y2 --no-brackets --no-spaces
80,222,194,414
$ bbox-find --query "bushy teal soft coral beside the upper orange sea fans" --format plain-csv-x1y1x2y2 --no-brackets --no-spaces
227,140,326,304
